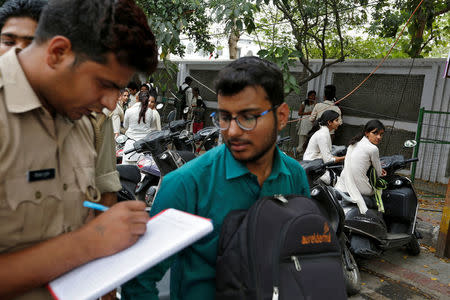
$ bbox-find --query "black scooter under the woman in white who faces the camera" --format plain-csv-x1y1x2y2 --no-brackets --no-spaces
334,155,421,257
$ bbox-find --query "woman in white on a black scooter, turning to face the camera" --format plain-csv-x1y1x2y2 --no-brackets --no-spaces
335,120,386,213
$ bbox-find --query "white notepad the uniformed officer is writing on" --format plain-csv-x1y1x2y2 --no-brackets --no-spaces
48,209,213,300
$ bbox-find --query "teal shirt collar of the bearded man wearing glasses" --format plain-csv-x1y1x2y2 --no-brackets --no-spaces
224,145,289,180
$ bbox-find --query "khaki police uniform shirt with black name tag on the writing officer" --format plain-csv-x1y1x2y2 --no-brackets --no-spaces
0,51,120,300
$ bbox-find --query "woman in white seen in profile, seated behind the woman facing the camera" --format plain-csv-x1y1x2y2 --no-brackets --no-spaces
303,110,345,184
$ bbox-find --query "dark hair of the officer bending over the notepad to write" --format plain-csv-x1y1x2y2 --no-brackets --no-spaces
35,0,158,73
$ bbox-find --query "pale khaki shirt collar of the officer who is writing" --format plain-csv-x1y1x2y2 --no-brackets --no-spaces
0,48,42,113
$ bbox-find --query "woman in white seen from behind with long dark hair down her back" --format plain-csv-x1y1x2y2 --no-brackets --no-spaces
123,91,161,164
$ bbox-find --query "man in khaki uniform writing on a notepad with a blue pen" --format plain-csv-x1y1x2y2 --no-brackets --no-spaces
0,0,157,299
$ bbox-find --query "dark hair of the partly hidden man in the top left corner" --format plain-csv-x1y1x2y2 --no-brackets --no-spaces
0,0,47,30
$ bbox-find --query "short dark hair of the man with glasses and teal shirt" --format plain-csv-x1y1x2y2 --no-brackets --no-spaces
215,56,284,106
